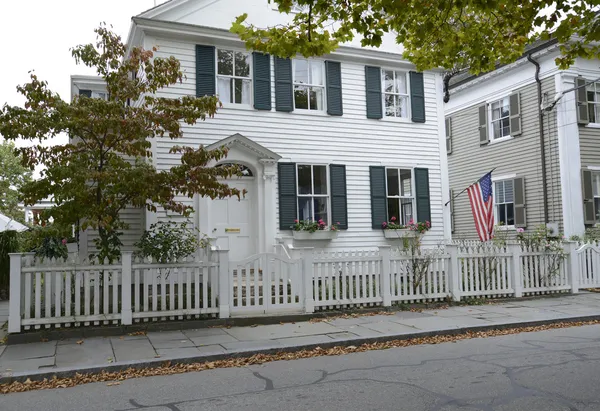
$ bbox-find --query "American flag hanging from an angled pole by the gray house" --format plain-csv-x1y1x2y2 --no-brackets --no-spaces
467,172,494,241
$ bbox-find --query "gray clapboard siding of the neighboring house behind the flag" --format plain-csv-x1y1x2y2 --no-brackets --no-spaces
448,77,562,238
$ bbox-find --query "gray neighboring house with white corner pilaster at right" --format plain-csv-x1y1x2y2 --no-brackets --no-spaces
445,40,600,238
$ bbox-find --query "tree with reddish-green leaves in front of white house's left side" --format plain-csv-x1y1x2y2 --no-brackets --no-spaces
0,25,242,259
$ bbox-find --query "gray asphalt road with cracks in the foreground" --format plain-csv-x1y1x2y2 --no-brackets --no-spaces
0,326,600,411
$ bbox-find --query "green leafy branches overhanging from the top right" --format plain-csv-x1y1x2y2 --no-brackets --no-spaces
231,0,600,74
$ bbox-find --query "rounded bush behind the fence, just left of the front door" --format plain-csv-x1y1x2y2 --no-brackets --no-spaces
135,221,208,263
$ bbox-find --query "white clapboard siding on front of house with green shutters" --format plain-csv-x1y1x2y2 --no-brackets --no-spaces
151,39,444,249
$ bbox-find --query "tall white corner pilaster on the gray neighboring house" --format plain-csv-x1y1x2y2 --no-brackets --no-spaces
547,72,585,238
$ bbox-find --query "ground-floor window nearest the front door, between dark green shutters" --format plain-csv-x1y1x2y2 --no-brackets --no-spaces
297,164,329,225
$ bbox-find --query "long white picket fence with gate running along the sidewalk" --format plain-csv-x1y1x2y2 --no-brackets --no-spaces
9,242,600,333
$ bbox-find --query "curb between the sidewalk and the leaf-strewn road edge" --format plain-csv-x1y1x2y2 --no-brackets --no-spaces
0,315,600,384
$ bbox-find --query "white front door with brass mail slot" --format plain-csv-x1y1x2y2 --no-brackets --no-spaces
209,178,258,261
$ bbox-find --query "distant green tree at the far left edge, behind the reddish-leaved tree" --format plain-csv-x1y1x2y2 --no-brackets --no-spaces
0,141,31,222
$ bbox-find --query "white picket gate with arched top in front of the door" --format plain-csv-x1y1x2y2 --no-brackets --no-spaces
229,253,303,316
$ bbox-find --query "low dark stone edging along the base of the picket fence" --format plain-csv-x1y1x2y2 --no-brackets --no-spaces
6,294,578,345
